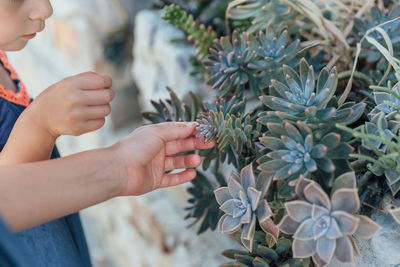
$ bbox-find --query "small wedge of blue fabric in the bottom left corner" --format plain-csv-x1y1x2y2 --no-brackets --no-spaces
0,218,34,267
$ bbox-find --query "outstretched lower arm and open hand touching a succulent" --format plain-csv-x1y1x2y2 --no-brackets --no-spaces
0,123,214,231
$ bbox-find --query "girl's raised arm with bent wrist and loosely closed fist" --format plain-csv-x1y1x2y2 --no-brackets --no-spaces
0,72,114,165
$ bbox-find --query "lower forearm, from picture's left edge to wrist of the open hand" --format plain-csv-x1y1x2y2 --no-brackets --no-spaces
0,148,123,231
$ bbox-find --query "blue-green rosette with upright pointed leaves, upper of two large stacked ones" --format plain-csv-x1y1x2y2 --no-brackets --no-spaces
259,58,365,124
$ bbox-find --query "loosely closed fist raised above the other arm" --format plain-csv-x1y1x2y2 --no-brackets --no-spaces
27,72,114,138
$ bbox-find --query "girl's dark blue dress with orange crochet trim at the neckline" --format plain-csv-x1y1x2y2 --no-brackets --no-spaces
0,51,91,267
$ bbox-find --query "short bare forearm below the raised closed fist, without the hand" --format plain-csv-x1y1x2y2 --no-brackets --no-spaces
0,107,56,166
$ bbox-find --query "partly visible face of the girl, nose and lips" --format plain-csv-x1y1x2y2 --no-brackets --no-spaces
0,0,53,51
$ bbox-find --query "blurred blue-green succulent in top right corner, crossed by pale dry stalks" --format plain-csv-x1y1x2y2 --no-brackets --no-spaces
354,4,400,70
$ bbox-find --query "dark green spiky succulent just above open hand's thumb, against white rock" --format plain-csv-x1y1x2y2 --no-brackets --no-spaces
142,87,205,123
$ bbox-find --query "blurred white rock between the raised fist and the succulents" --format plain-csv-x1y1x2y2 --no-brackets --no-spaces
132,10,211,110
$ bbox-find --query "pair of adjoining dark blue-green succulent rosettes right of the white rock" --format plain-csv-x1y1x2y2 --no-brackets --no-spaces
203,26,299,97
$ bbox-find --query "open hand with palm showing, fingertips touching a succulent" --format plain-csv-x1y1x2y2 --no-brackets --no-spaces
113,122,214,196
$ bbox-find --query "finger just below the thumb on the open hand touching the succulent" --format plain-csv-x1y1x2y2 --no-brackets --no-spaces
165,137,215,156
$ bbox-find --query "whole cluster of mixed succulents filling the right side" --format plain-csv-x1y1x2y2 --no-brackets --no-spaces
144,0,400,267
